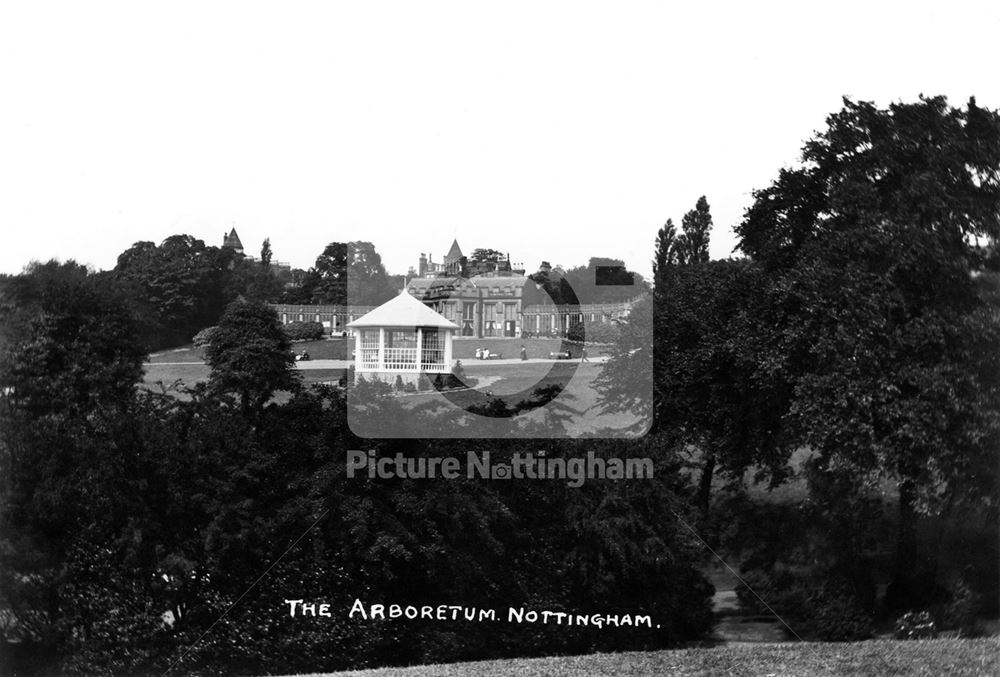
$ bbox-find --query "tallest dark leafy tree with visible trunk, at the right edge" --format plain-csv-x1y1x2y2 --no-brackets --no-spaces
737,97,1000,604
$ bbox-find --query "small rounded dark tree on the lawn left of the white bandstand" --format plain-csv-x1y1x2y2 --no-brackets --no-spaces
205,301,299,414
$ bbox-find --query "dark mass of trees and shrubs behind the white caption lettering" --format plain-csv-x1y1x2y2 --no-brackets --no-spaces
0,258,711,674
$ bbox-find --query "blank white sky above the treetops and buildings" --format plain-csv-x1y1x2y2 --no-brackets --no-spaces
0,0,1000,275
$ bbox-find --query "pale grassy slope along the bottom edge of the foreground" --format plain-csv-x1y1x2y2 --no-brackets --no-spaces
286,637,1000,677
